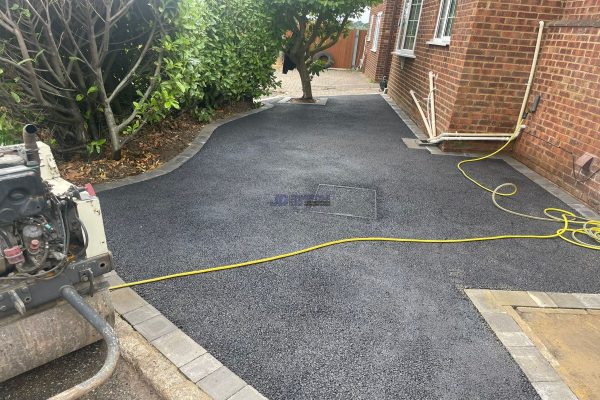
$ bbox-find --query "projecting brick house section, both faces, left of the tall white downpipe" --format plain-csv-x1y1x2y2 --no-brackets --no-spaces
389,0,561,133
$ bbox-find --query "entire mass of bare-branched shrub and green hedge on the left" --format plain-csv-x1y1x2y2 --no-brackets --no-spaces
0,0,279,158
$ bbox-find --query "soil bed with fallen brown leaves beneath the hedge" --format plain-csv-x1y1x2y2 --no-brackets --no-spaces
56,102,254,185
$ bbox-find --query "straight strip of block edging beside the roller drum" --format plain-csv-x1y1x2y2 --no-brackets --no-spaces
104,271,267,400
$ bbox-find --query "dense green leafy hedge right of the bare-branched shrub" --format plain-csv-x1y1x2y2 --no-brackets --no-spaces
130,0,279,129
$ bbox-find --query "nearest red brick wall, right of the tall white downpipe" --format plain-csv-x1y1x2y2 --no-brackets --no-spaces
514,21,600,209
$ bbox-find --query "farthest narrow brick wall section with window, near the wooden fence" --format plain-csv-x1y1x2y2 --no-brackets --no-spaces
364,0,400,82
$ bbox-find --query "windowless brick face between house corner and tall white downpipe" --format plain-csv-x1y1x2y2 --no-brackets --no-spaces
449,0,562,133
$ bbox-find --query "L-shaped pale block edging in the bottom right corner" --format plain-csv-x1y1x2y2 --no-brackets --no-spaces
465,289,600,400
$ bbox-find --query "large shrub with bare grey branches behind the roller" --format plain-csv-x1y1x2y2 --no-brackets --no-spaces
0,0,166,159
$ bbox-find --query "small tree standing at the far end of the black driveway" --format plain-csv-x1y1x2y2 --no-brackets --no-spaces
266,0,381,100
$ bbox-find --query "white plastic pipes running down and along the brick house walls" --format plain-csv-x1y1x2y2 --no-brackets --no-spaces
418,21,544,144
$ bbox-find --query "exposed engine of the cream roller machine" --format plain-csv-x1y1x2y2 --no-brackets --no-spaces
0,149,86,278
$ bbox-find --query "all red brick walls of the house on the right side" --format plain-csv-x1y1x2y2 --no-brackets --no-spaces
365,0,600,209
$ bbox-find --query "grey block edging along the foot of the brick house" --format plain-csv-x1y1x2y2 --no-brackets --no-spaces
381,94,600,219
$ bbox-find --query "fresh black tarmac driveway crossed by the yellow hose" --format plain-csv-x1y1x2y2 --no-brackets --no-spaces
100,95,600,400
